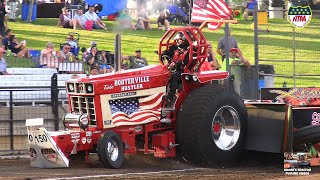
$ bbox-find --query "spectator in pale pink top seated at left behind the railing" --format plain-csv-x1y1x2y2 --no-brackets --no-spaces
40,42,59,68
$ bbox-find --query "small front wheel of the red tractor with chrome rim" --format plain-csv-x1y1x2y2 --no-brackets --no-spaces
98,131,124,169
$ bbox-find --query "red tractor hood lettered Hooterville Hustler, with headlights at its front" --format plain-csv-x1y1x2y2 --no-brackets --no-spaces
66,65,170,95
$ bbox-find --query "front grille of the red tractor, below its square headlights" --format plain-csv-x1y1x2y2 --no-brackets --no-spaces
71,96,97,125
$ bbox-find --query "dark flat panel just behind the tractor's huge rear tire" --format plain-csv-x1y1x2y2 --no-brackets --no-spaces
245,103,288,153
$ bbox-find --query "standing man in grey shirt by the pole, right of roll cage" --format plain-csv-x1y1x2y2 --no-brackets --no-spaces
217,28,240,61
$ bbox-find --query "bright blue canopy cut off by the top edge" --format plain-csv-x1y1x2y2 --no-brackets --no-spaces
86,0,127,17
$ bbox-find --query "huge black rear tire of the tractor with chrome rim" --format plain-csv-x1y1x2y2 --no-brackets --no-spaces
177,84,247,163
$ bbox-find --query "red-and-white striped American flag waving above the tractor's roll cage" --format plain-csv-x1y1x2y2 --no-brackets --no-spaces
191,0,232,30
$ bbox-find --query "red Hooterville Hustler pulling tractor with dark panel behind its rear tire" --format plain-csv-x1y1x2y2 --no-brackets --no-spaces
27,27,292,168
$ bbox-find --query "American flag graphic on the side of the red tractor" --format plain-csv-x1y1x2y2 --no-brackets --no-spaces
109,93,164,126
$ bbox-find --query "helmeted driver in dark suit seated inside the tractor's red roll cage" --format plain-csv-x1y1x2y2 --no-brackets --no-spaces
161,32,190,108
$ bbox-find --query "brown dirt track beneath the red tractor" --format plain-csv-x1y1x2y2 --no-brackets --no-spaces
0,151,320,180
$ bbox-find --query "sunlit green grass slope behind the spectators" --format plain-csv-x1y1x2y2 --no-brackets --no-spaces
5,16,320,85
